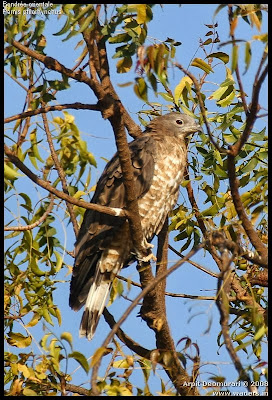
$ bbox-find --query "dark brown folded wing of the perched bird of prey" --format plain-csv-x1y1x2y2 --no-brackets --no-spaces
70,135,156,309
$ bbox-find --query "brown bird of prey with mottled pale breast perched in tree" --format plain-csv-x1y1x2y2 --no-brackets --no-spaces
69,112,201,340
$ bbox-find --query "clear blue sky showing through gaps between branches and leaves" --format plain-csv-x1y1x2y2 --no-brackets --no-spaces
5,4,267,396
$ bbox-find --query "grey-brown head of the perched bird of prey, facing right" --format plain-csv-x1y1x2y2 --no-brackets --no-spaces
146,112,202,138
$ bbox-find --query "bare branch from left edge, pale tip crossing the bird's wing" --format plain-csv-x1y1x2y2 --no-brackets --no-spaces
4,145,128,217
